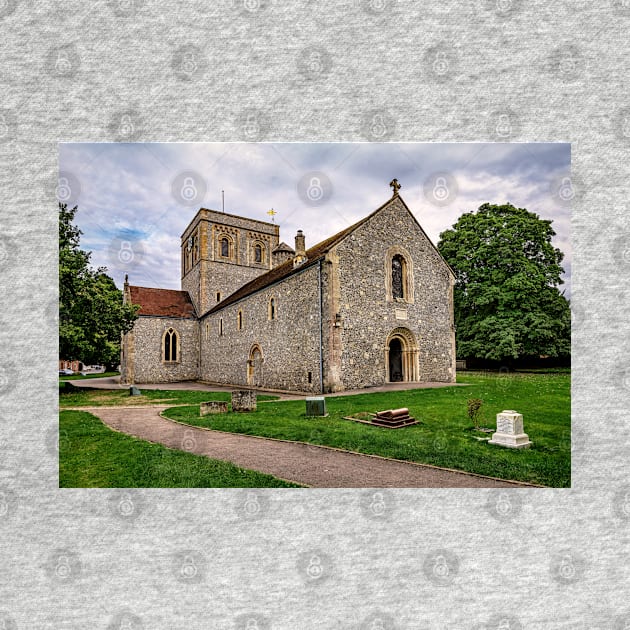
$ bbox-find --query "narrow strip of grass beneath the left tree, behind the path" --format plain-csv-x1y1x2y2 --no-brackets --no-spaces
59,385,278,409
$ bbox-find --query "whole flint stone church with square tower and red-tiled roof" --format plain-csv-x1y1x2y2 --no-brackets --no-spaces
121,180,455,393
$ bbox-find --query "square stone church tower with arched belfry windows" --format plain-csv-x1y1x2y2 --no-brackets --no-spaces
181,208,280,316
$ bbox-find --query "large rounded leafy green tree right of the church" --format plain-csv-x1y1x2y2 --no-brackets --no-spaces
438,203,571,364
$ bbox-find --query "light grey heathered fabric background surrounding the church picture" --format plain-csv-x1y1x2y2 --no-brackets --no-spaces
0,0,630,629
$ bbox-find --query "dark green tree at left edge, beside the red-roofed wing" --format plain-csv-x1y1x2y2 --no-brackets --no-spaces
59,203,138,369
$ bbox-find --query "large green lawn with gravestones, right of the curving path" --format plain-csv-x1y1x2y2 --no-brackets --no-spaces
165,372,571,487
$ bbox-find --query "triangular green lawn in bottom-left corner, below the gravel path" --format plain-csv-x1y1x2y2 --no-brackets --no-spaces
59,412,299,488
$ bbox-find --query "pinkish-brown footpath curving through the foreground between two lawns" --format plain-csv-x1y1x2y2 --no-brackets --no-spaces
76,405,527,488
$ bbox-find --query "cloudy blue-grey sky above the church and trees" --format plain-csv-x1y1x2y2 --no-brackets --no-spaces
57,143,572,297
